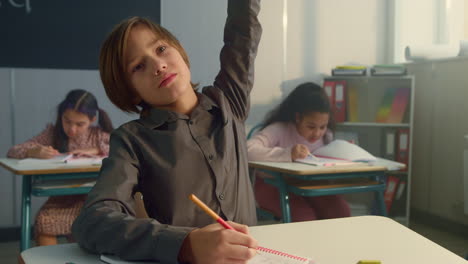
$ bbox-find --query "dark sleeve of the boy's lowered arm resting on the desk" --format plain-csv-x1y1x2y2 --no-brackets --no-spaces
72,128,193,263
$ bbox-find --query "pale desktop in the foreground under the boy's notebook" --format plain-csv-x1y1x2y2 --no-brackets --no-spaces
21,216,467,264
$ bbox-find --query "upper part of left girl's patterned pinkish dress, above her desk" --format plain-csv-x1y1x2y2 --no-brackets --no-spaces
7,124,109,159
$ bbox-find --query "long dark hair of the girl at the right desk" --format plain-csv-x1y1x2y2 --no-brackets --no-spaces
262,82,335,131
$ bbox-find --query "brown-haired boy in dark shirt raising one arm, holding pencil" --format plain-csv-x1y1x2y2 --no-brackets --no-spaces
72,0,261,263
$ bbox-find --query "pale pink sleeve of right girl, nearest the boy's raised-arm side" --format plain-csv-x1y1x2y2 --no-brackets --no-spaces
247,123,292,161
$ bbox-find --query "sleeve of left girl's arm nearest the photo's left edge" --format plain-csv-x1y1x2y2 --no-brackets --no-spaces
7,124,54,159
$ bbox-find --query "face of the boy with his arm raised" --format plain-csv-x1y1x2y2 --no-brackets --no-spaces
124,25,194,110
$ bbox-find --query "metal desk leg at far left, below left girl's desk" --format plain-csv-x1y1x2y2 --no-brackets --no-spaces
20,175,32,251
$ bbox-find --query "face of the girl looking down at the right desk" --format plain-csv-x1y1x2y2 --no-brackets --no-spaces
296,112,329,143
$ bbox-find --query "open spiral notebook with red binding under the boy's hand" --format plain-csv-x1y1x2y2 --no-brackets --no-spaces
101,247,318,264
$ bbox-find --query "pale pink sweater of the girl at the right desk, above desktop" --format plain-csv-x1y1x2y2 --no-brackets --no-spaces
247,122,333,161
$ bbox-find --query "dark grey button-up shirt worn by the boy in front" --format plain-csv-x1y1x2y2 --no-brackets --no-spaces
72,0,261,263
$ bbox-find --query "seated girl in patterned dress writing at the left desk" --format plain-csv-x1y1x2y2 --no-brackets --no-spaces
7,90,112,246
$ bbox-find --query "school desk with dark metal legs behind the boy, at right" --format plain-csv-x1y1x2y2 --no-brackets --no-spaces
249,161,387,223
